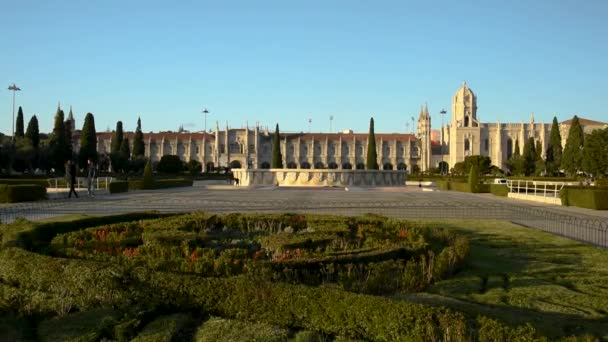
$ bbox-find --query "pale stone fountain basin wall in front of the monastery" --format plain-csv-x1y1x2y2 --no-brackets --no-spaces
232,169,407,187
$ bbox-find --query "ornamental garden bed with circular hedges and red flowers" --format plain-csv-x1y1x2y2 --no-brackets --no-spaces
0,213,604,341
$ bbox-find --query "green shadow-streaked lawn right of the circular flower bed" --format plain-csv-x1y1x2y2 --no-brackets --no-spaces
399,220,608,339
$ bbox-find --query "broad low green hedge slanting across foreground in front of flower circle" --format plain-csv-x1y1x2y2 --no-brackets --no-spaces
0,248,538,341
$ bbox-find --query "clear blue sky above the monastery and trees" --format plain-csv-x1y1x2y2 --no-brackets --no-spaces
0,0,608,134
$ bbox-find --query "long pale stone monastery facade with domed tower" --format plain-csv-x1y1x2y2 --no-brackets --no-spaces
72,82,607,171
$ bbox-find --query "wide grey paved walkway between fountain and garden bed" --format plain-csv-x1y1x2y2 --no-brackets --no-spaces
0,182,608,247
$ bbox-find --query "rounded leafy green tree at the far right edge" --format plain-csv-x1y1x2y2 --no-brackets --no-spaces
583,128,608,178
